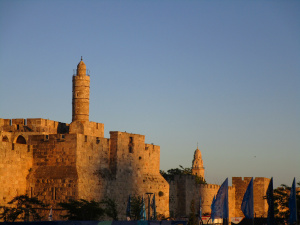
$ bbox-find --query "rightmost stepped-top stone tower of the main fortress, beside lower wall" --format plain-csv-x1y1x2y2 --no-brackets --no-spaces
109,131,169,219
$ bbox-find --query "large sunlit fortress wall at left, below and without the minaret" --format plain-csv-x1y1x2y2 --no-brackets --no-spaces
0,119,169,220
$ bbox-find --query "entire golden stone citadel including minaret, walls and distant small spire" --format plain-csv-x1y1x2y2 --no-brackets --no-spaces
0,59,270,220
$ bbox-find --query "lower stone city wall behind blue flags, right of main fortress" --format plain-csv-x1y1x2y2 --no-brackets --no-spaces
169,175,270,218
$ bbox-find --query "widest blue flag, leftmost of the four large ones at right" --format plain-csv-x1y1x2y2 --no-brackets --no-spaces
211,178,228,221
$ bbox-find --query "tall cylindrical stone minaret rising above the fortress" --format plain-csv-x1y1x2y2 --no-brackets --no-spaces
72,57,90,122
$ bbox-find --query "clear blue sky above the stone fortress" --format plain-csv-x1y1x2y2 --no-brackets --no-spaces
0,0,300,186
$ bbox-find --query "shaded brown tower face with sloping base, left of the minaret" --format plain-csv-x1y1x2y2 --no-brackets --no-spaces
27,134,78,205
